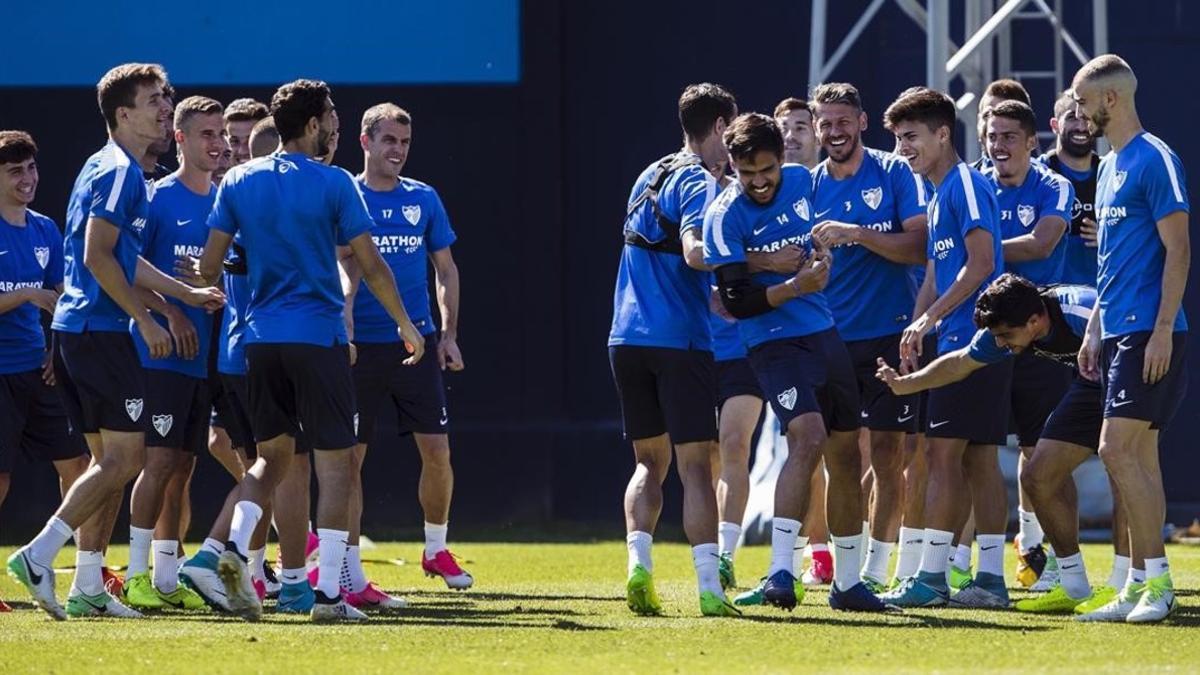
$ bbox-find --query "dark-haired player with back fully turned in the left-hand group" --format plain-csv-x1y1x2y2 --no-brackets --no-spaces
199,79,424,621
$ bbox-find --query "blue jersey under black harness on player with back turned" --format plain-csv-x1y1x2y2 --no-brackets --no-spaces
608,151,716,351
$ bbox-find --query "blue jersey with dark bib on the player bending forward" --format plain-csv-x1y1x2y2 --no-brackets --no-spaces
967,285,1096,368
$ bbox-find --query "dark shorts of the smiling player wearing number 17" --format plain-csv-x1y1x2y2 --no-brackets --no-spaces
354,334,450,443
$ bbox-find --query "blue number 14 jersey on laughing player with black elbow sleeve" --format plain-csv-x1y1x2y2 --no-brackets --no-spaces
704,165,833,347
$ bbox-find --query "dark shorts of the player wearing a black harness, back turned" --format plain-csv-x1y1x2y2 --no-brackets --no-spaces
608,345,716,444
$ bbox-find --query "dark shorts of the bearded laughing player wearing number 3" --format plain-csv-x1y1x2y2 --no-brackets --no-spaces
846,334,920,434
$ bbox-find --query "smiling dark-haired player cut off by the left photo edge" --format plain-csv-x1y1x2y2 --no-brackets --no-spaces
0,131,88,611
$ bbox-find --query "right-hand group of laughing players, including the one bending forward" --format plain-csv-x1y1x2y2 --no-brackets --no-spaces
608,54,1189,622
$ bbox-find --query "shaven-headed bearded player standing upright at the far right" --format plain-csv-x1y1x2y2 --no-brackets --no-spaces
1072,54,1190,623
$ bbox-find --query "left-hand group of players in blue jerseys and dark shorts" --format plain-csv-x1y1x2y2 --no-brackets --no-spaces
0,64,473,621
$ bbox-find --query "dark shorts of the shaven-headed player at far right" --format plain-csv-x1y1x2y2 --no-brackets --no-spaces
1100,330,1188,429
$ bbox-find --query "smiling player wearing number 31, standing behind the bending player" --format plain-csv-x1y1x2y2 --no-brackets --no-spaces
984,101,1075,590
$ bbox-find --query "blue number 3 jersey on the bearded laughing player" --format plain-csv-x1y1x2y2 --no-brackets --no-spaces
812,148,928,340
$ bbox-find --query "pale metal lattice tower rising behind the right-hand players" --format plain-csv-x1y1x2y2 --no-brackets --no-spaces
809,0,1109,161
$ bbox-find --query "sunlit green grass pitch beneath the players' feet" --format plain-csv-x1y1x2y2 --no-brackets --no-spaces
0,542,1200,674
